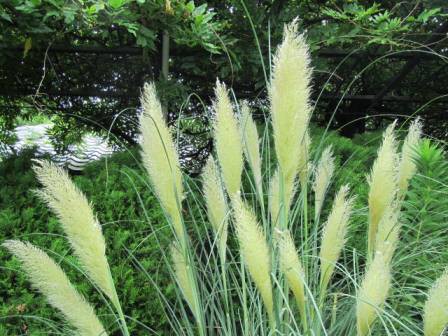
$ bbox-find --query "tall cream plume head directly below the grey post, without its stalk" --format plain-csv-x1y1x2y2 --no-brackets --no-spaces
140,83,184,241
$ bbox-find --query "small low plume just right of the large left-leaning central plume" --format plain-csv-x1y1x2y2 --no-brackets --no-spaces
278,231,306,319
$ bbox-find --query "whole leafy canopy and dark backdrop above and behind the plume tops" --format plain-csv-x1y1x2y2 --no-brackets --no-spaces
0,0,448,156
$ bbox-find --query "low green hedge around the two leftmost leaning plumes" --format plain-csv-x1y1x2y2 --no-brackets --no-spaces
0,151,172,335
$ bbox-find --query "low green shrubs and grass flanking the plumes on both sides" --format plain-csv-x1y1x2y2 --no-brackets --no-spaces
0,128,448,335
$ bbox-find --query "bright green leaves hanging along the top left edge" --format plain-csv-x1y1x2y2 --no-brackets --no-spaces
0,0,220,52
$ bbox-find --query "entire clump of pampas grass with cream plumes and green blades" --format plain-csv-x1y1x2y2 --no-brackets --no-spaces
3,21,448,336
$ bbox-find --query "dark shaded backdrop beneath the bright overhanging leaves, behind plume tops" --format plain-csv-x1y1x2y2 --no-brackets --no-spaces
0,1,448,170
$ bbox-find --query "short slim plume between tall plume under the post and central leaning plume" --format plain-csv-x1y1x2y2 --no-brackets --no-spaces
202,155,228,256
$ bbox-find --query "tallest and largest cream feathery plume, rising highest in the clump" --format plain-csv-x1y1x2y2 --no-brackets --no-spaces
269,20,311,180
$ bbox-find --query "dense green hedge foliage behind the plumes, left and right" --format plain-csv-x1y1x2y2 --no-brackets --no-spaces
0,125,448,335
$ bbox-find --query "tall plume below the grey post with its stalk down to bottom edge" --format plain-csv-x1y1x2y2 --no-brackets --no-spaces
140,84,204,335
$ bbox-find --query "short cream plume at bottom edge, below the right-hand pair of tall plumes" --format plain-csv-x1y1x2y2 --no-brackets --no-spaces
356,253,392,336
